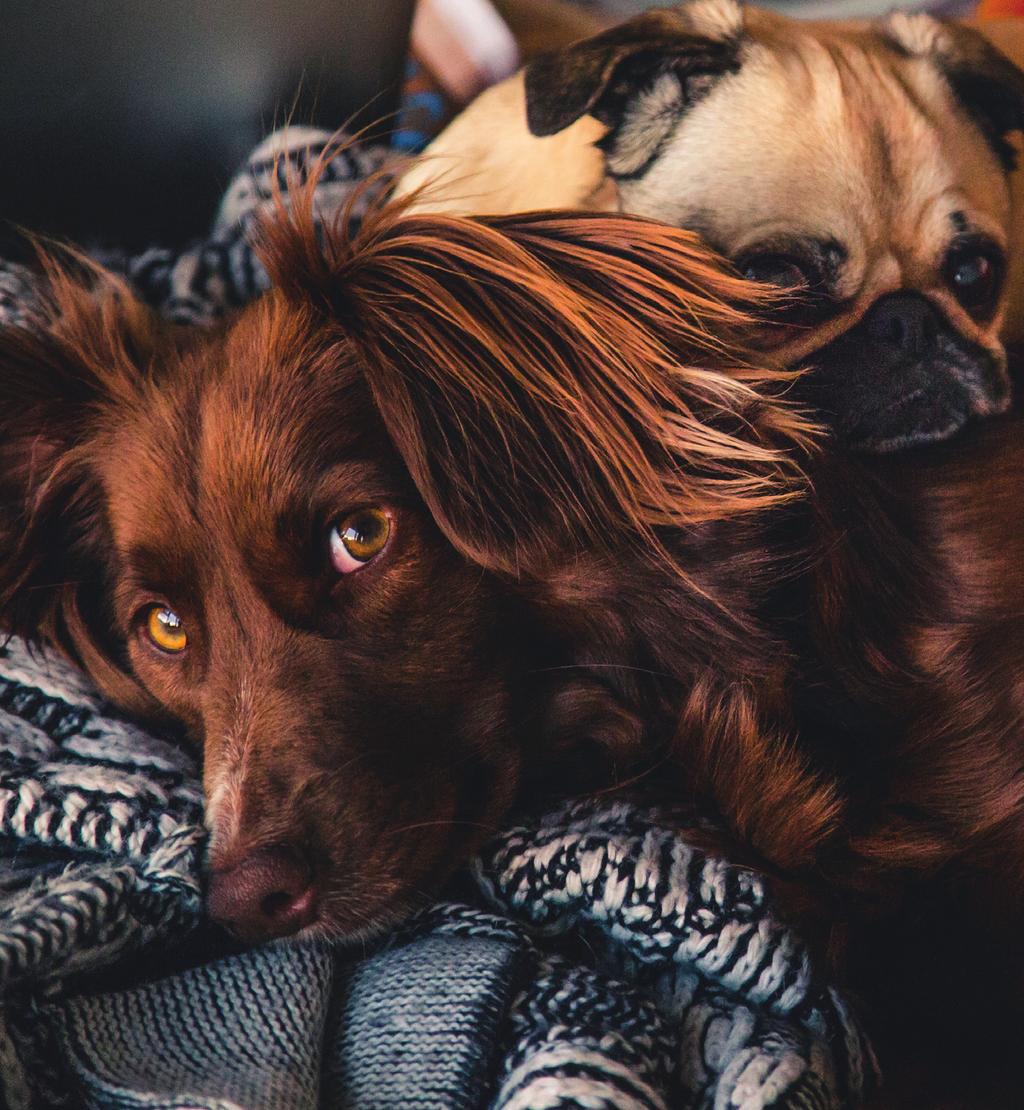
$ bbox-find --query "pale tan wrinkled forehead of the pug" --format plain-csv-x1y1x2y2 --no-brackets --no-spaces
619,21,1007,264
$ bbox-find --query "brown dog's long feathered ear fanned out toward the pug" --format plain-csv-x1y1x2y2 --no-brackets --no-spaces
266,202,807,574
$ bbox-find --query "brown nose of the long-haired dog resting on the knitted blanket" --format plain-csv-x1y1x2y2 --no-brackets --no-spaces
206,846,316,941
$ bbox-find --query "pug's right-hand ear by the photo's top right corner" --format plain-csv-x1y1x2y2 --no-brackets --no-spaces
886,13,1024,172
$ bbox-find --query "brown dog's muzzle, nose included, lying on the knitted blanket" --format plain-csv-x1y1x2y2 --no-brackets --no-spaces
204,676,518,944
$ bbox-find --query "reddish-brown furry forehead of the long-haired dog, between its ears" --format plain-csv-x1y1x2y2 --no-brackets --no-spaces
99,297,368,546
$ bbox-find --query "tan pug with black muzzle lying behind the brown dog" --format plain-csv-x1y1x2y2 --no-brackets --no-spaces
398,0,1024,452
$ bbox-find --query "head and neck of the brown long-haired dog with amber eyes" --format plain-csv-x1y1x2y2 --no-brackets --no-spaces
0,204,837,938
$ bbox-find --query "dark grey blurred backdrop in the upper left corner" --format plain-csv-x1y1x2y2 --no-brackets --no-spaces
0,0,413,256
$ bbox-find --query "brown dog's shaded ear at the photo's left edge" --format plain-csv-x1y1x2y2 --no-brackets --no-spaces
0,262,158,708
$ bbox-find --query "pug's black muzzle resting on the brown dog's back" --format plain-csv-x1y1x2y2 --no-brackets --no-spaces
800,293,1010,454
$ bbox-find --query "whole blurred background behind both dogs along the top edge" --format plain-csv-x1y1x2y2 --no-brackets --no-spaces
0,0,1011,256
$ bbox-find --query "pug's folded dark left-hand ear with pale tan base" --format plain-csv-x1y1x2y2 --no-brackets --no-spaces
526,0,742,135
